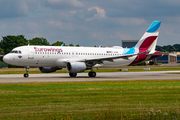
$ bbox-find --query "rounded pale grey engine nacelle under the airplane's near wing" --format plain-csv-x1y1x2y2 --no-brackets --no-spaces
66,62,86,73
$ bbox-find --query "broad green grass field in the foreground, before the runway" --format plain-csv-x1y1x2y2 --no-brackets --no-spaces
0,80,180,120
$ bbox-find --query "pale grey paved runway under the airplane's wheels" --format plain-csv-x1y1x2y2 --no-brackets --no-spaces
0,71,180,83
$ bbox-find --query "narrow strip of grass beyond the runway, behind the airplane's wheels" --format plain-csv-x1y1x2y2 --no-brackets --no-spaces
0,66,180,74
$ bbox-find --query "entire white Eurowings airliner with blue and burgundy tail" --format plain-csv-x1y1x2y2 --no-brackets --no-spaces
3,21,163,77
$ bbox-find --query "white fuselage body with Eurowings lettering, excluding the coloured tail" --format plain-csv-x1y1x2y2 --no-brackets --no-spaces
3,46,136,68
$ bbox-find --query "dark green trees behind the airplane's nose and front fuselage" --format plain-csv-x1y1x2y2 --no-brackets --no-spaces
0,35,79,54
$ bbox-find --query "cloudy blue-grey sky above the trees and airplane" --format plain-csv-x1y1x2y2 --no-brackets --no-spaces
0,0,180,46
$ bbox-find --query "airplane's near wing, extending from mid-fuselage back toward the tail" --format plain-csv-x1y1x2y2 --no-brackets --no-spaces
78,51,149,62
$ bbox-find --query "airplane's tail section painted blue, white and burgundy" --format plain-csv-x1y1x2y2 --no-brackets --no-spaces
128,21,162,65
